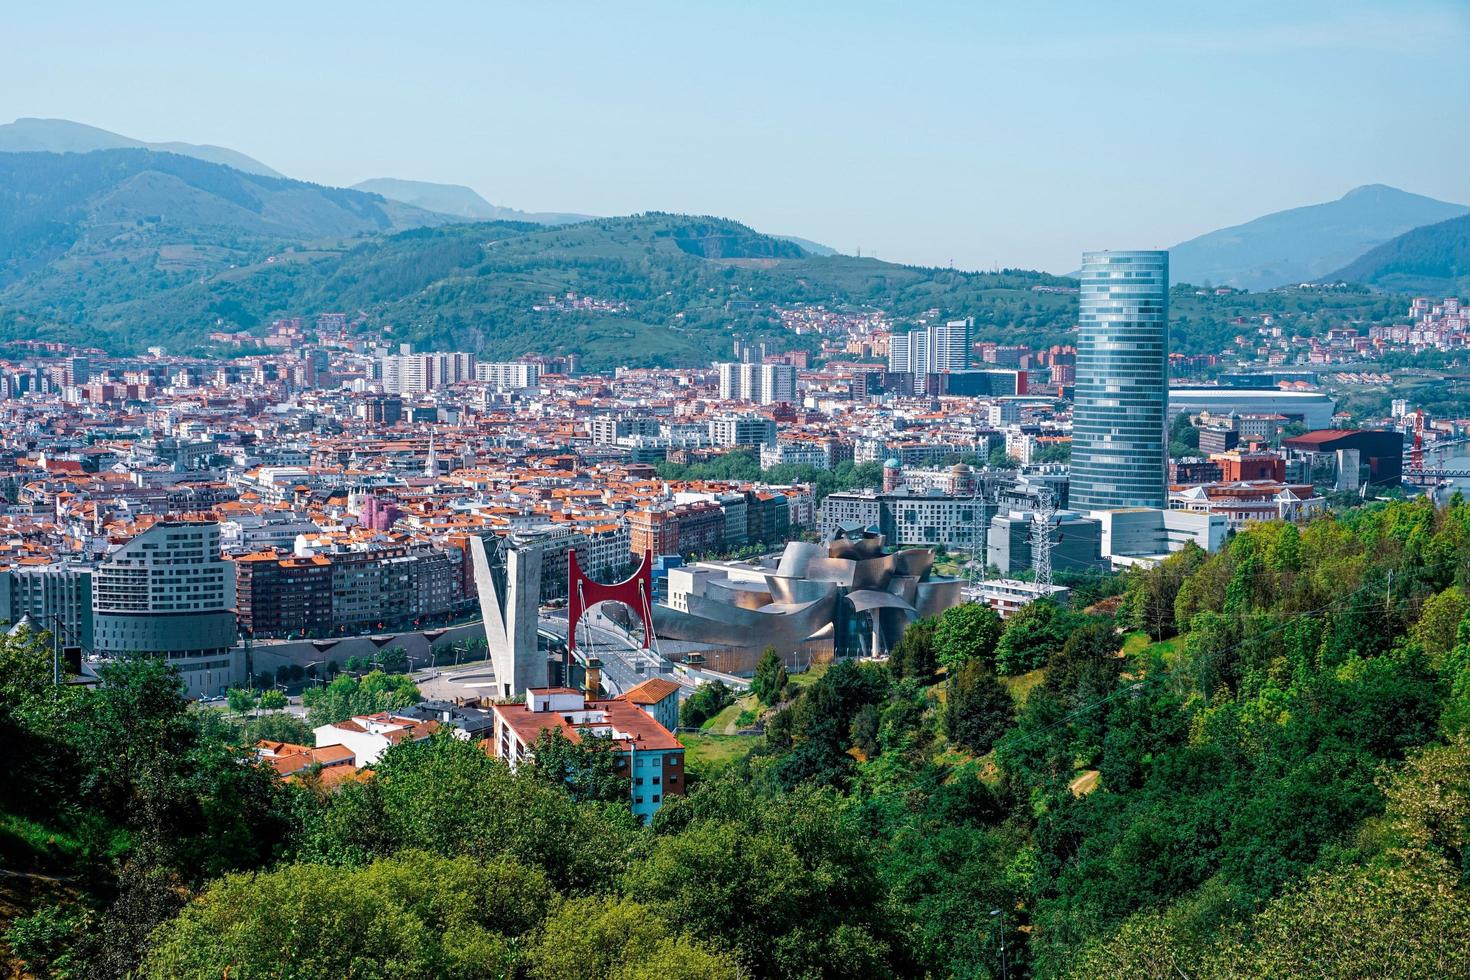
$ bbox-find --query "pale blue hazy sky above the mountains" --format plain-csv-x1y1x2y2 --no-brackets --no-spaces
0,0,1470,272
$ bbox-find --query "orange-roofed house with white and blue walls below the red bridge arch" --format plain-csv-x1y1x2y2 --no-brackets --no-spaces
481,685,684,821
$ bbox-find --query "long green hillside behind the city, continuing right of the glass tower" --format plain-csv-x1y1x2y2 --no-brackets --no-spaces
0,150,1401,369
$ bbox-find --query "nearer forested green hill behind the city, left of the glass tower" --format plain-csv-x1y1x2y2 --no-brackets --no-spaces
0,196,1075,367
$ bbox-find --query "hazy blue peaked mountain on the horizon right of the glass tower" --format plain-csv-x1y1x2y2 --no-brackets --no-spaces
1169,184,1470,289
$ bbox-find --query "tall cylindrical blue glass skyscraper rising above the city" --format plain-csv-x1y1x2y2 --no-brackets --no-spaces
1069,251,1169,511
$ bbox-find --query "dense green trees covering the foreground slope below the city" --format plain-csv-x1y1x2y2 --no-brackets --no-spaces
0,501,1470,979
